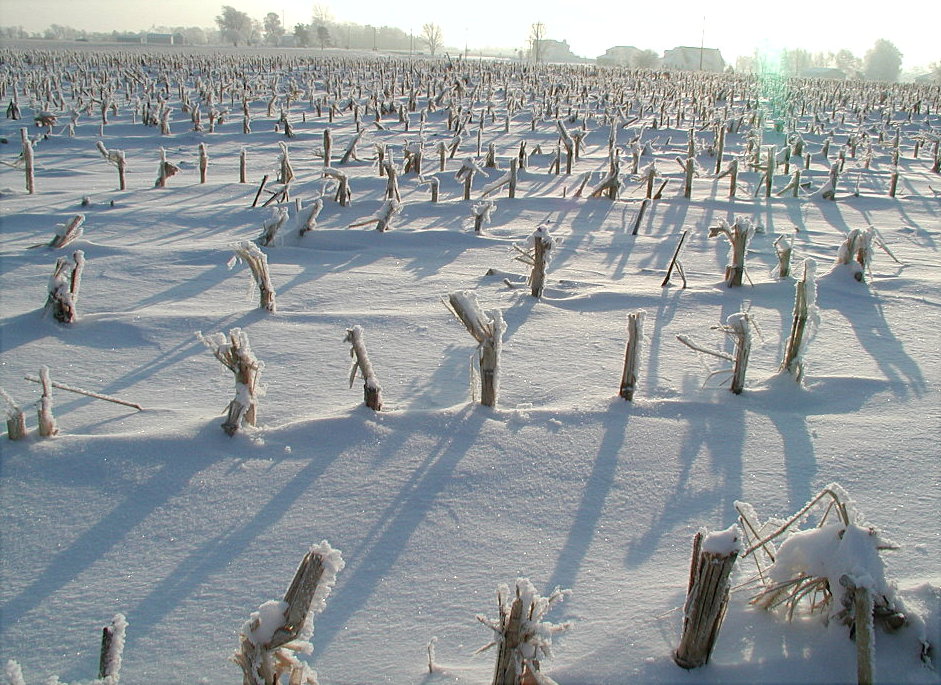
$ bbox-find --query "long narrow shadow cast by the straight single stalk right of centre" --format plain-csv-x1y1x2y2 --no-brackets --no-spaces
546,402,630,591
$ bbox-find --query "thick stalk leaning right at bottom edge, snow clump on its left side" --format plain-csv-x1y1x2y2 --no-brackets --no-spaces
233,540,344,685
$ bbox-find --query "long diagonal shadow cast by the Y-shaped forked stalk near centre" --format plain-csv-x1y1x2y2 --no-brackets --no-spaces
314,405,490,661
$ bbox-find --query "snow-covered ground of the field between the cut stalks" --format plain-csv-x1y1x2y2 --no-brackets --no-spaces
0,45,941,685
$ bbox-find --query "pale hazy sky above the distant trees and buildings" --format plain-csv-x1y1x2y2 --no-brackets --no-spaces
0,0,941,68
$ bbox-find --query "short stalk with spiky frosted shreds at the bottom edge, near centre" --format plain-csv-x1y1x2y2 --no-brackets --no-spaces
476,578,572,685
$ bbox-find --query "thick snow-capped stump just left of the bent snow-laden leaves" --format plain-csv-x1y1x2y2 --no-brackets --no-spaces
673,525,742,669
